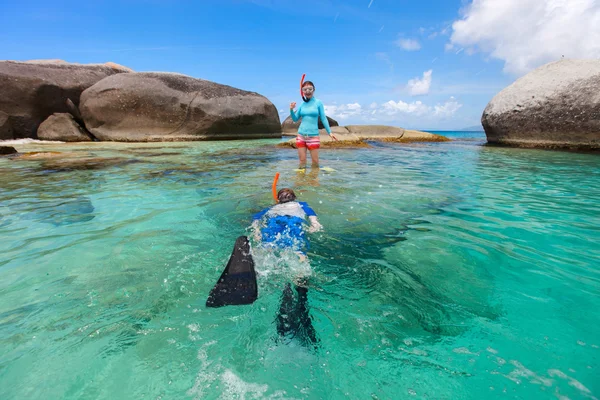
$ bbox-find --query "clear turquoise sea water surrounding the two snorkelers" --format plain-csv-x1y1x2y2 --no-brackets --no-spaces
0,133,600,399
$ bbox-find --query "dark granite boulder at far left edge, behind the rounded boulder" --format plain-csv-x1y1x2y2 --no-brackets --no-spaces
0,60,127,139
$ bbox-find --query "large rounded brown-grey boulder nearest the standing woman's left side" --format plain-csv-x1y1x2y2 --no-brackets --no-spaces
79,72,281,142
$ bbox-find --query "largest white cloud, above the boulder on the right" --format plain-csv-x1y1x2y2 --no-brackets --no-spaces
450,0,600,75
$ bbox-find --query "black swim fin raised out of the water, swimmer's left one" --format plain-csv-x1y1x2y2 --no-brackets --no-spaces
206,236,258,307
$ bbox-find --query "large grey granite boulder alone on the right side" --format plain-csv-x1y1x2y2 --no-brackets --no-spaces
481,60,600,149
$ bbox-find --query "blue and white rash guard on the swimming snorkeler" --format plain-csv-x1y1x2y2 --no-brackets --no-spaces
253,201,317,251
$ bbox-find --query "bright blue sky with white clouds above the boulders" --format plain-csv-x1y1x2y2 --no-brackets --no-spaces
0,0,600,130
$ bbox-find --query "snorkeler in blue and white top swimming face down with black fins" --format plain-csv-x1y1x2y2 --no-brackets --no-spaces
206,186,323,346
